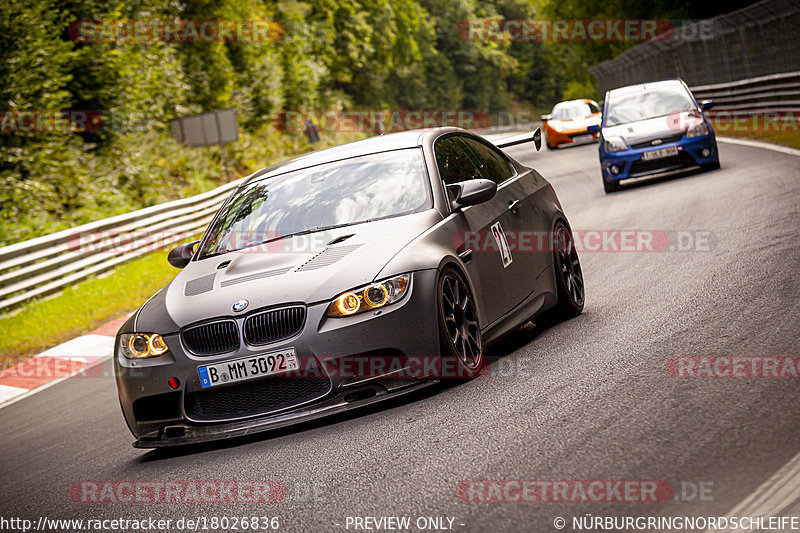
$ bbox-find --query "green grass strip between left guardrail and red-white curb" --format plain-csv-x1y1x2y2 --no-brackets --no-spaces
0,247,178,368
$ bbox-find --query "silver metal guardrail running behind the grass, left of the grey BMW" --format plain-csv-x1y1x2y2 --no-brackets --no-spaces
0,178,244,312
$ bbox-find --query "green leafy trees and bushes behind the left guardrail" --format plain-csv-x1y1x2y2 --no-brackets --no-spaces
0,0,744,245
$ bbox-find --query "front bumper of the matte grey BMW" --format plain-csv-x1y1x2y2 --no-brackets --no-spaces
114,269,439,448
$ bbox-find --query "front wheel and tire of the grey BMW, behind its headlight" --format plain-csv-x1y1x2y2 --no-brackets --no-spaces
436,267,484,379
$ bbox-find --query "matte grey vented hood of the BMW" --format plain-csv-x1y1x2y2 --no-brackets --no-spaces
153,210,442,328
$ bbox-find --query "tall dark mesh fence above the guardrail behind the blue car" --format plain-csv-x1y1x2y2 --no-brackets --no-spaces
589,0,800,96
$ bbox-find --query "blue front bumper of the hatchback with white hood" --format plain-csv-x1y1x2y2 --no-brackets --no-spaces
600,134,719,182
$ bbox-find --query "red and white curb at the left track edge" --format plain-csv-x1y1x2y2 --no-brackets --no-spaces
0,316,128,409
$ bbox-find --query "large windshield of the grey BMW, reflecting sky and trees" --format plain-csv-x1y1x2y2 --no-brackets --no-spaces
198,148,431,259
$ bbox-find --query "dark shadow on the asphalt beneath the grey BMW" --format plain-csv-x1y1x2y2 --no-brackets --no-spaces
134,319,560,464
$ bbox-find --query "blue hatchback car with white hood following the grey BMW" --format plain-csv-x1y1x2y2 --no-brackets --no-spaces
599,79,719,193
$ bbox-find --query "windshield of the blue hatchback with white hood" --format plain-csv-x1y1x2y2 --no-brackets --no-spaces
606,85,695,126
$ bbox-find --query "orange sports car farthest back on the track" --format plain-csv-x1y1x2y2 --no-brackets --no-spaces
542,98,602,150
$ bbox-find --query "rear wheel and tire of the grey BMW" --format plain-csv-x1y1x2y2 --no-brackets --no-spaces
548,222,586,320
